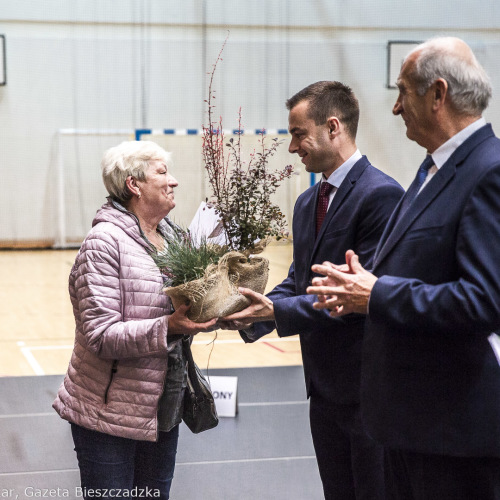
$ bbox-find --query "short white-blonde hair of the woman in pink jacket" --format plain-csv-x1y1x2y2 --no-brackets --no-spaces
101,141,172,202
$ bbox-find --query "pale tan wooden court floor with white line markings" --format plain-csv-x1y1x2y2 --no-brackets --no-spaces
0,243,302,376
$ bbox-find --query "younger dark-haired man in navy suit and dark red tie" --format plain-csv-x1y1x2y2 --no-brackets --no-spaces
221,82,403,500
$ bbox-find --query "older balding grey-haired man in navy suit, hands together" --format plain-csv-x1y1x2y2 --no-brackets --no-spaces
308,38,500,500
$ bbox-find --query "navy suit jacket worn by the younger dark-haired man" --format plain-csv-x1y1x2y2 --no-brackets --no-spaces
242,156,403,404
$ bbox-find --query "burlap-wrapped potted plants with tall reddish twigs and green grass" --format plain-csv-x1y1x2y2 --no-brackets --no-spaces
155,39,292,322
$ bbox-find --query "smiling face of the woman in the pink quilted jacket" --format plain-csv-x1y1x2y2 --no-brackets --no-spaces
137,160,178,217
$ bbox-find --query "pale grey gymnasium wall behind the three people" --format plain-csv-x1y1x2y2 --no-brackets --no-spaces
0,0,500,246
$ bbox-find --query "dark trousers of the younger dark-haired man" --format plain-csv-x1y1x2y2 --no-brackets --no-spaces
310,395,385,500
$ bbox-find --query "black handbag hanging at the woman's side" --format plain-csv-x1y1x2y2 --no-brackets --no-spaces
182,339,219,434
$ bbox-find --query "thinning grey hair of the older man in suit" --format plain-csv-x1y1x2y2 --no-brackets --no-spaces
405,37,491,116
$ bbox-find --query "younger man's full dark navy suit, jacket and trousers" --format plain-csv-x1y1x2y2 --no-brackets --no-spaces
244,157,403,500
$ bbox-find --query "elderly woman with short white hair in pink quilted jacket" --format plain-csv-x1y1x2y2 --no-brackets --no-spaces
53,141,215,498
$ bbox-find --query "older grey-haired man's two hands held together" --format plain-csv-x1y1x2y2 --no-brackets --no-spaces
307,250,377,317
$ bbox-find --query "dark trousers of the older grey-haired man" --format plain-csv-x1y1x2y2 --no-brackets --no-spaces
385,450,500,500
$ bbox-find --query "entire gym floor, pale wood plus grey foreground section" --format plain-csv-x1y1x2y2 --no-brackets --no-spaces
0,244,322,500
